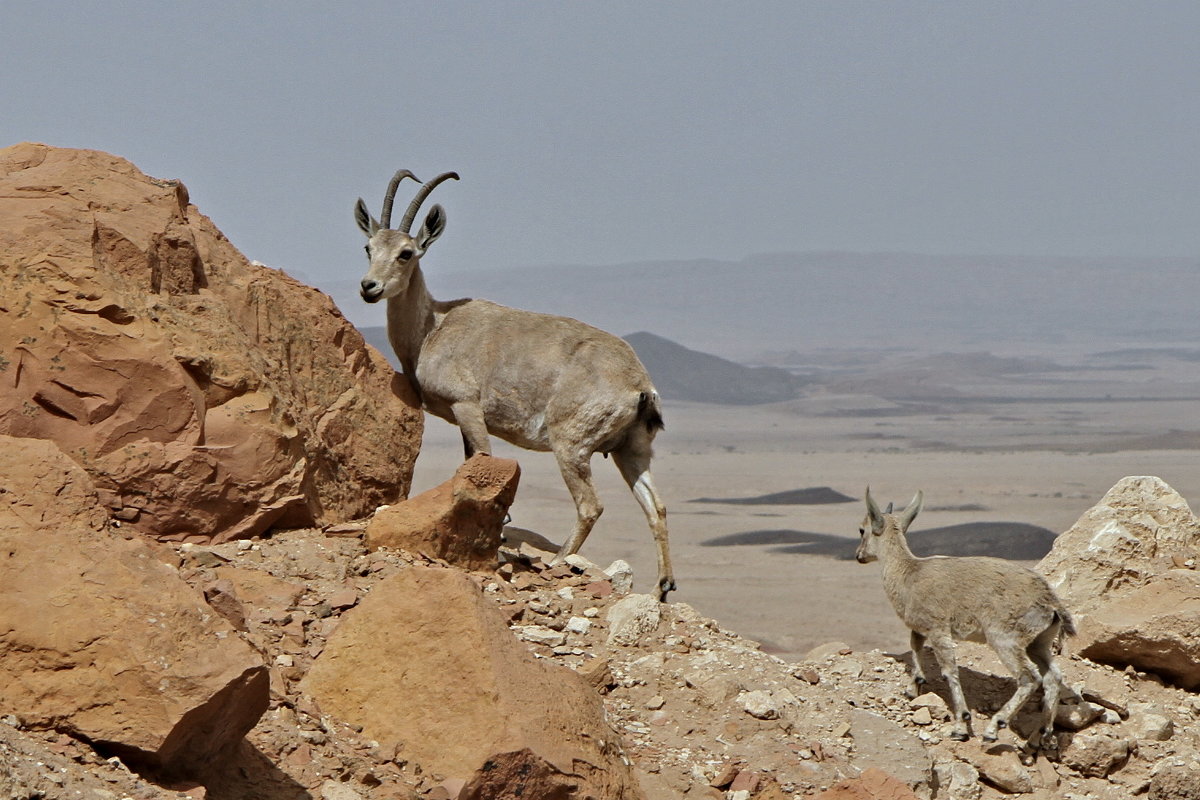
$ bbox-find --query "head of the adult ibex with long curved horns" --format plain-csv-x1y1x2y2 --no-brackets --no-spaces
354,169,458,302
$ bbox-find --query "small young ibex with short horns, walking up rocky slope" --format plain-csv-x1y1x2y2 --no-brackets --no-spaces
856,489,1075,751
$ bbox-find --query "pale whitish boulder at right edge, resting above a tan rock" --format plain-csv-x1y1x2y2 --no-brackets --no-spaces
1038,476,1200,621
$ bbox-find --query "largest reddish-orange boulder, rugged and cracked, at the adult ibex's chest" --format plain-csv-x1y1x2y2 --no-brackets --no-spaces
0,144,421,542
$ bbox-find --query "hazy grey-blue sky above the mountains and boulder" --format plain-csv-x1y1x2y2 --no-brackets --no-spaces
0,0,1200,303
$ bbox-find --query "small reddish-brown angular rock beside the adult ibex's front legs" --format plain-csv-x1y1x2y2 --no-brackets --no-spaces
366,453,521,570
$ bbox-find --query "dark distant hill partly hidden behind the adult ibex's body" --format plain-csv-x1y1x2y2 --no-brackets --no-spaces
359,326,800,405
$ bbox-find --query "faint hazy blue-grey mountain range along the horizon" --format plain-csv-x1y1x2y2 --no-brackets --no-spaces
323,252,1200,360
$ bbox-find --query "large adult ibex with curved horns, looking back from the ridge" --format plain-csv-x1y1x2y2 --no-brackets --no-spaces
354,169,676,600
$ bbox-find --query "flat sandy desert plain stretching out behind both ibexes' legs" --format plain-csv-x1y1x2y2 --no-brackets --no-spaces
414,348,1200,660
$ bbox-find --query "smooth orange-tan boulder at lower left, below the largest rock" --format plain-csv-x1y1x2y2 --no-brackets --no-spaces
0,437,269,775
